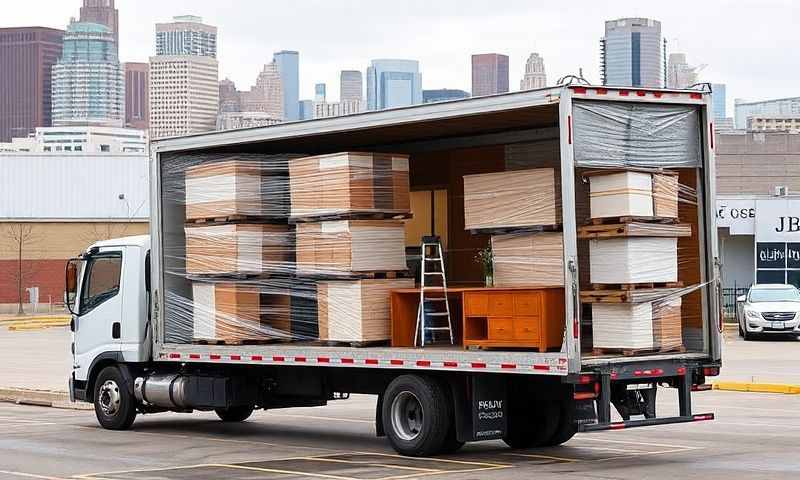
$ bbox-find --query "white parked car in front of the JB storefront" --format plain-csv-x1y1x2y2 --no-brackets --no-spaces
736,283,800,340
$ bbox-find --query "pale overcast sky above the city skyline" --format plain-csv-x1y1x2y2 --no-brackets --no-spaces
0,0,800,112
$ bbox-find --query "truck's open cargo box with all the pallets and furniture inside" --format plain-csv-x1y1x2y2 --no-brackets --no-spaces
153,87,717,375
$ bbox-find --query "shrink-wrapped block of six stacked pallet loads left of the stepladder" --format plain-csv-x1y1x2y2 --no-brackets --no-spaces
161,153,414,344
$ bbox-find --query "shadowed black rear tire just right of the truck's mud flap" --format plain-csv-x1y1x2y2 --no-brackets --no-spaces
503,400,561,448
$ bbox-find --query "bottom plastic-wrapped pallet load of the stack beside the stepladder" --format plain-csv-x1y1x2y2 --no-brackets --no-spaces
318,278,414,343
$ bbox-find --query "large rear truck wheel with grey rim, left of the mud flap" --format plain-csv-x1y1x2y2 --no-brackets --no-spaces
381,375,456,457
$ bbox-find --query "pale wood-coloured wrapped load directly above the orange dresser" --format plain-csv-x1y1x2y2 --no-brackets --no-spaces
492,232,564,287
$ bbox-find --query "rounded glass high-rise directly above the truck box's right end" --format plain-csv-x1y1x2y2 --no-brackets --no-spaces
600,18,666,88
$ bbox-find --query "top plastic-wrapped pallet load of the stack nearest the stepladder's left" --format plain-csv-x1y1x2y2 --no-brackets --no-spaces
289,152,411,218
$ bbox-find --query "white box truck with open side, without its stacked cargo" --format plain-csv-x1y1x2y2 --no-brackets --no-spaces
66,84,721,455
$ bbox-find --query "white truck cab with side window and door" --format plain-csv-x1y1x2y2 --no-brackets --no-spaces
65,235,151,402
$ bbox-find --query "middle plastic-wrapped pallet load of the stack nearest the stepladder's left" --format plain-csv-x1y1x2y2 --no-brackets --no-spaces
297,220,406,274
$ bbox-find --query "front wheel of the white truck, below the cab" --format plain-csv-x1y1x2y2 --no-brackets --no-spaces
94,366,136,430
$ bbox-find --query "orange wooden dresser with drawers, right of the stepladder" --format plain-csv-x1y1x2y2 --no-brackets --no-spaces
463,288,565,352
